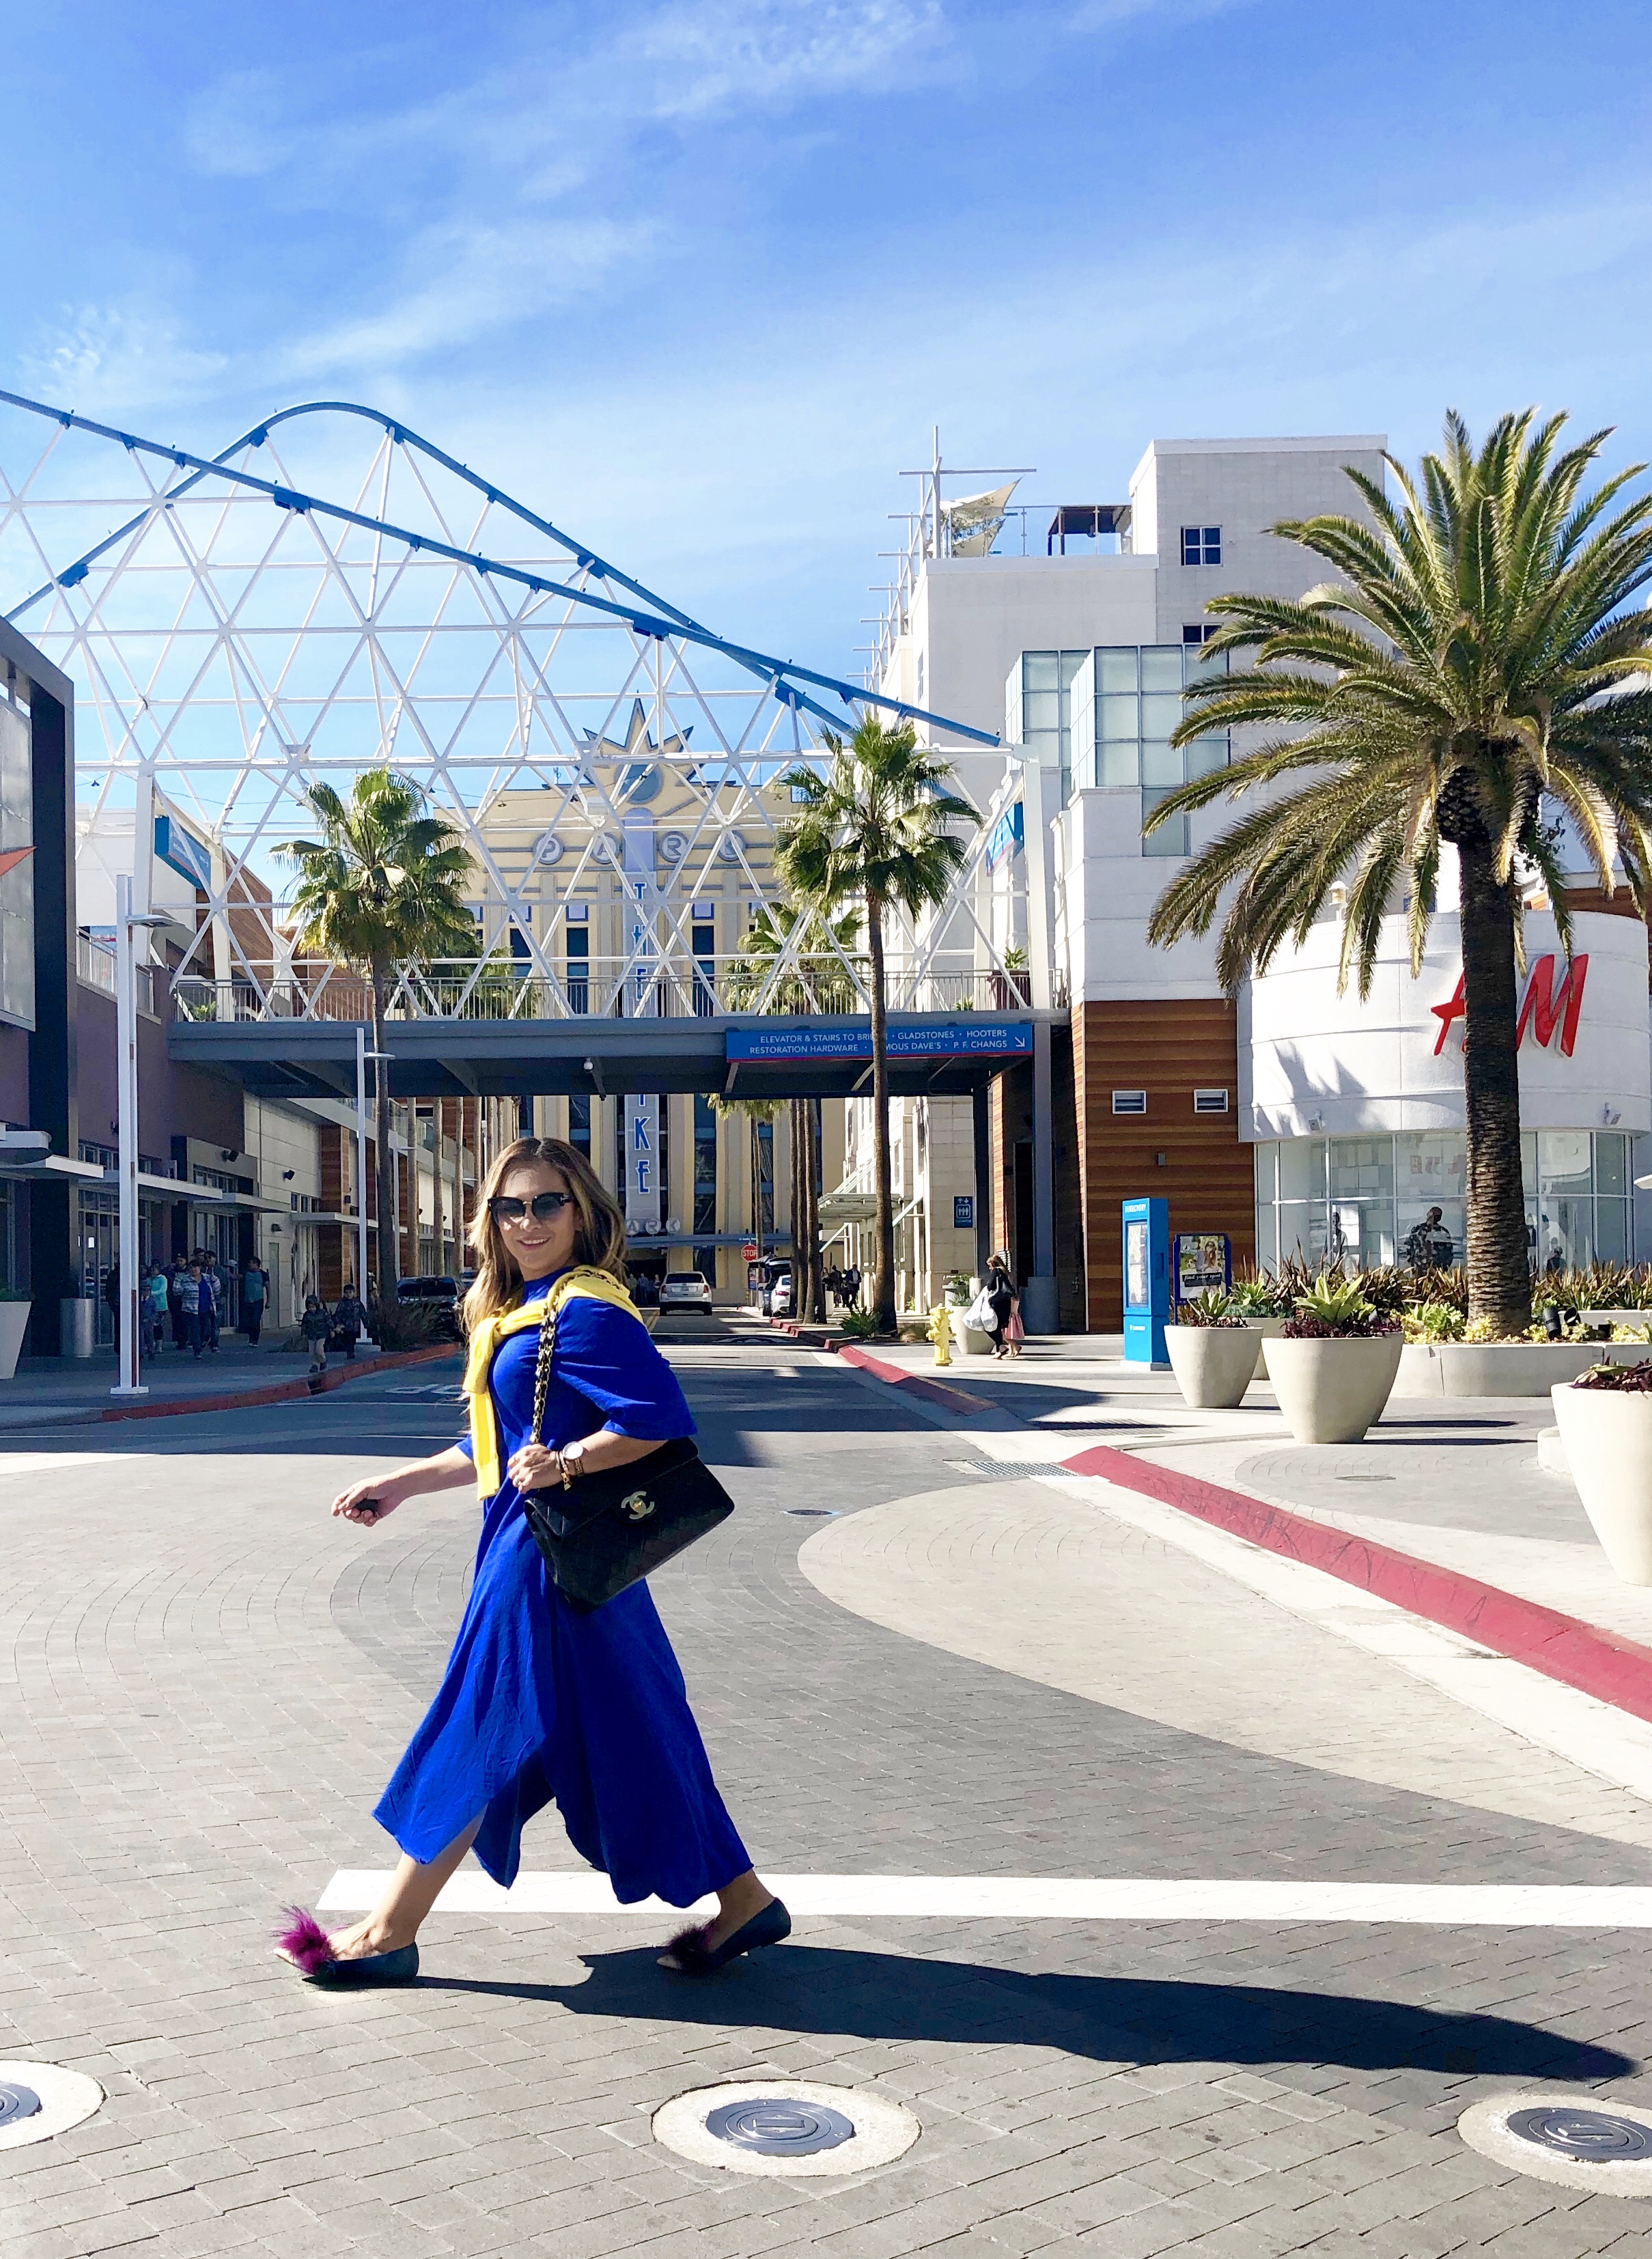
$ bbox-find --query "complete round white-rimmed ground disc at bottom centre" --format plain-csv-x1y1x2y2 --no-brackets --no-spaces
653,2078,922,2178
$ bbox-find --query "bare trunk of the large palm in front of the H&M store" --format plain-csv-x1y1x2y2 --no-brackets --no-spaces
1457,838,1532,1333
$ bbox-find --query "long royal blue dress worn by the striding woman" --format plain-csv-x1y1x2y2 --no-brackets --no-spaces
373,1278,753,1907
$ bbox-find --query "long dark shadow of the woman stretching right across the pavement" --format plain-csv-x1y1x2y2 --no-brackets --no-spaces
423,1945,1638,2078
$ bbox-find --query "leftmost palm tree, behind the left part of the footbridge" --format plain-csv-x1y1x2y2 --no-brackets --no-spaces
276,768,477,1313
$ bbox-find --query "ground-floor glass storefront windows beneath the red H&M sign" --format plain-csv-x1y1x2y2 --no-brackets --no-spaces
1255,1130,1632,1272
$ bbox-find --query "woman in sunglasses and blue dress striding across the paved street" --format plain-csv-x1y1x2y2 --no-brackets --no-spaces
278,1138,791,1986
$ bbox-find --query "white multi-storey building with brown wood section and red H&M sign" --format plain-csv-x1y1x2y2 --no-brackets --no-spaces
877,436,1652,1330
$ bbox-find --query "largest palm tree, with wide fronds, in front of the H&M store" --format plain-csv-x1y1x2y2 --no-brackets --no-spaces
1148,409,1652,1330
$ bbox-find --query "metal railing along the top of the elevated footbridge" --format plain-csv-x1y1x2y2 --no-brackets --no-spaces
171,955,1048,1021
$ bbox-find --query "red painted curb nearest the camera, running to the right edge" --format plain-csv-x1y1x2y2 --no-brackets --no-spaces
1060,1444,1652,1722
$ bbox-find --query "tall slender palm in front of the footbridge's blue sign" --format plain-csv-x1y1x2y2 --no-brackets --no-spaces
775,714,981,1333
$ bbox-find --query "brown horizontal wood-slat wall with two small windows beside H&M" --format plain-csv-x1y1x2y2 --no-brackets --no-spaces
1074,996,1257,1333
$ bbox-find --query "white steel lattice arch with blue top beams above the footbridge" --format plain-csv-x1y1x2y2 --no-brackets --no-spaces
0,393,1019,1019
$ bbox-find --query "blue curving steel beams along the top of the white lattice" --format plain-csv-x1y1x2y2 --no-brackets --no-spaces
0,391,999,746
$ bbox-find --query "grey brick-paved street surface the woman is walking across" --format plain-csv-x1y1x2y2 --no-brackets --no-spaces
0,1321,1652,2259
